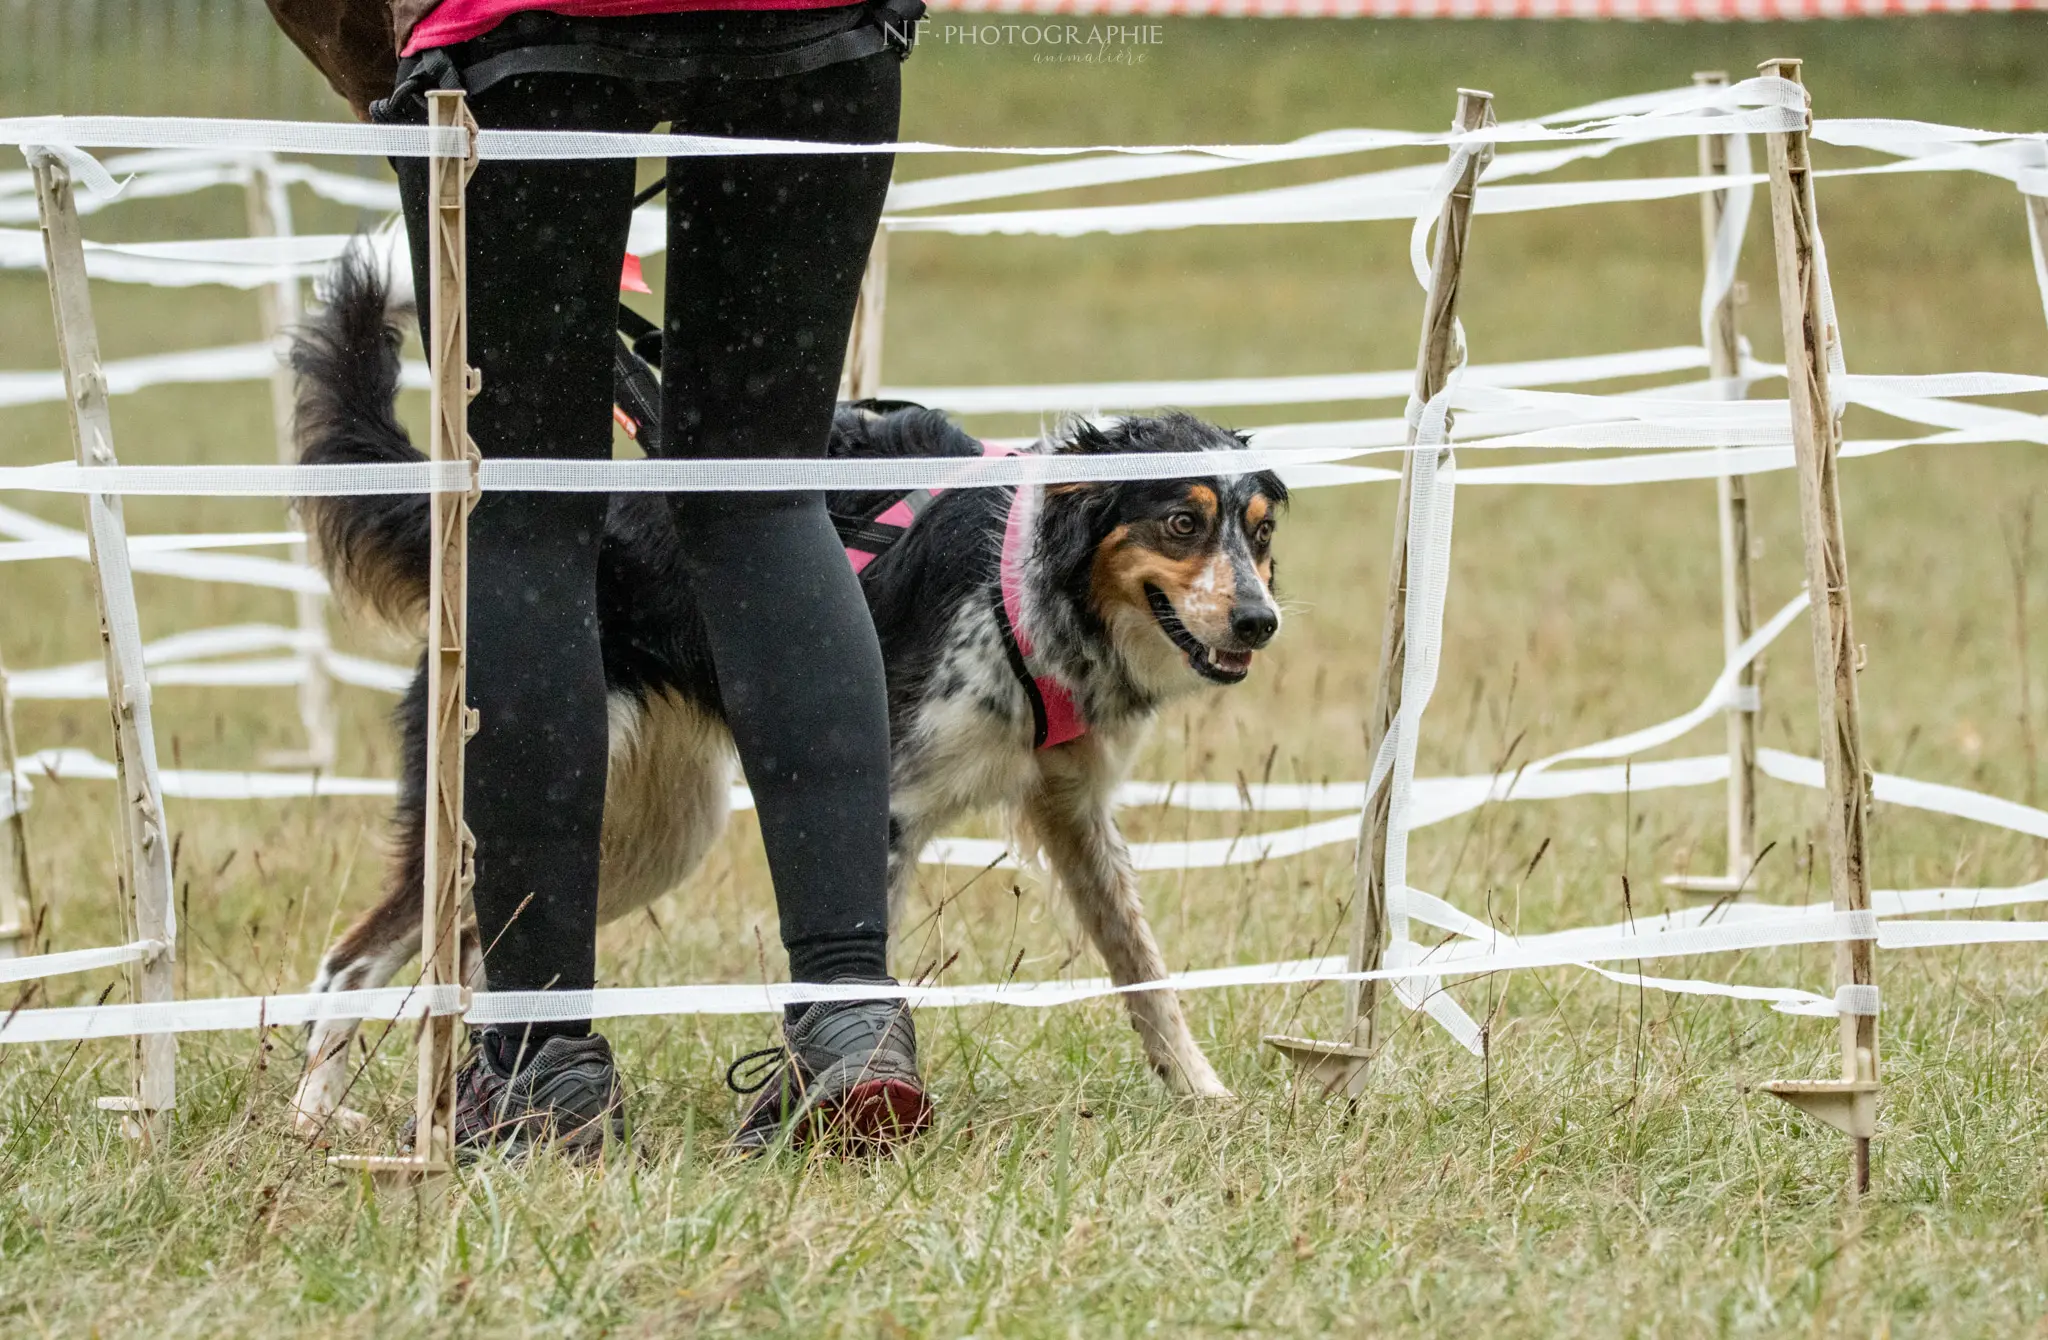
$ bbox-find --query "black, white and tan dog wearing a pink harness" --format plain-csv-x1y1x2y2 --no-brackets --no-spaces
291,258,1288,1135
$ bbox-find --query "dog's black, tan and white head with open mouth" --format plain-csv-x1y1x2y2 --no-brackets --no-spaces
1038,414,1286,695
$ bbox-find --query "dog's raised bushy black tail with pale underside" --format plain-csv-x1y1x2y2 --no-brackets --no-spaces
291,248,430,627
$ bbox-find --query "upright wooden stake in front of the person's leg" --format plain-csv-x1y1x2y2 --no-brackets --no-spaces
330,90,481,1180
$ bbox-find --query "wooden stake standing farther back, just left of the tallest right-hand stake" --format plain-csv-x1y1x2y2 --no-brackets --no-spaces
1665,70,1757,897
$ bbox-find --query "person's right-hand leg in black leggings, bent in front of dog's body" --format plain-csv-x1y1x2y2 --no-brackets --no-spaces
662,53,901,981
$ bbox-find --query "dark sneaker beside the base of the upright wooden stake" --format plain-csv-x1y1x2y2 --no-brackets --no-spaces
397,1029,627,1160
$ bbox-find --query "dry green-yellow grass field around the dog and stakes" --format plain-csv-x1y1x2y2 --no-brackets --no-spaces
0,16,2048,1336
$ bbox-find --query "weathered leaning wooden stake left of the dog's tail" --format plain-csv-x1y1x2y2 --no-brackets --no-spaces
31,150,178,1141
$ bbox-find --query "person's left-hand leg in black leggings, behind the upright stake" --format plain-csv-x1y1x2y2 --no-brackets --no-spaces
387,76,645,1061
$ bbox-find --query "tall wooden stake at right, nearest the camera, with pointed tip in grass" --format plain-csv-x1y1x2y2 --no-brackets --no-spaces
1761,59,1878,1195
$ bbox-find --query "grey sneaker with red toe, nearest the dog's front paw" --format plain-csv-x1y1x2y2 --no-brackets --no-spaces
725,977,932,1156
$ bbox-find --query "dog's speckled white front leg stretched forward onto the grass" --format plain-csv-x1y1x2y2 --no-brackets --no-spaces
1024,742,1231,1098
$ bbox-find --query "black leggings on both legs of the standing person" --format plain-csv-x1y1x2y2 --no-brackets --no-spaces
399,42,901,1031
